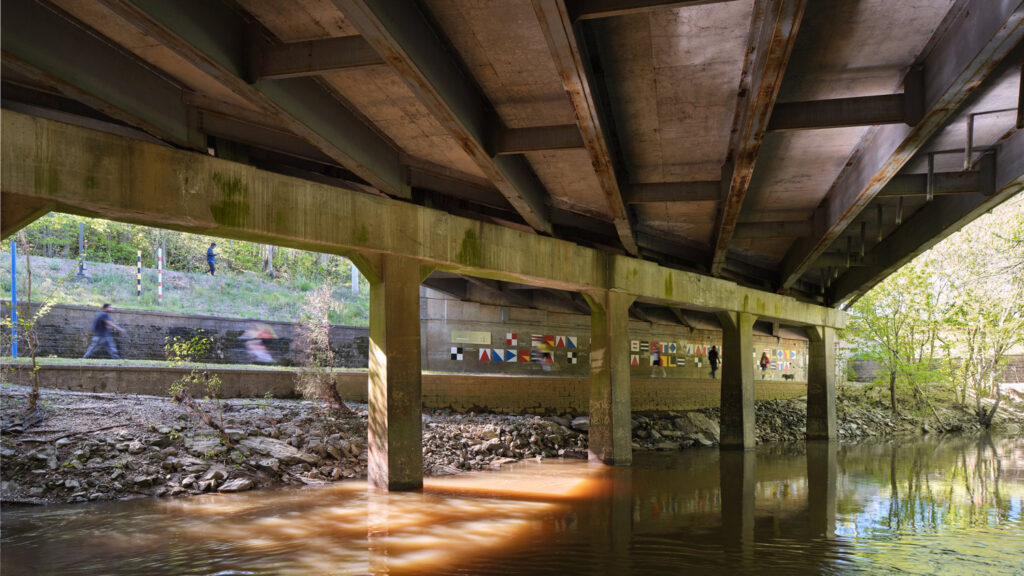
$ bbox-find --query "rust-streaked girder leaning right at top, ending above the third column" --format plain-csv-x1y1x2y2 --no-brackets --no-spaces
711,0,807,276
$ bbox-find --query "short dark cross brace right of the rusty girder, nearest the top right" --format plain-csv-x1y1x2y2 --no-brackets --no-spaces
768,94,909,132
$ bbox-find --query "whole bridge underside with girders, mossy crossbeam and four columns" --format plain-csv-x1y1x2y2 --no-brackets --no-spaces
0,0,1024,489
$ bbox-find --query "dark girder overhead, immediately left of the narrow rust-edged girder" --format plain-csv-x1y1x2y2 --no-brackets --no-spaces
333,0,551,234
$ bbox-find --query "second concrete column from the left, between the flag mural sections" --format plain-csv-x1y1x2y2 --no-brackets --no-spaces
584,290,635,466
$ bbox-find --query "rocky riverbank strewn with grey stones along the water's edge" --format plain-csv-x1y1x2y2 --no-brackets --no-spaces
0,385,1024,504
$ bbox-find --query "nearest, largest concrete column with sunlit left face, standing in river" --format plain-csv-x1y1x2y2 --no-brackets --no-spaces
362,254,429,490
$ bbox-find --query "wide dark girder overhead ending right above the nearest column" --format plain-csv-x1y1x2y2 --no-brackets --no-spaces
102,0,410,199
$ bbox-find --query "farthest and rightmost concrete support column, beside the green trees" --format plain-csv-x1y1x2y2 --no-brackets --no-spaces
807,326,839,440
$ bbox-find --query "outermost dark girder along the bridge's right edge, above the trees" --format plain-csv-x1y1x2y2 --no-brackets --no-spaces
831,130,1024,302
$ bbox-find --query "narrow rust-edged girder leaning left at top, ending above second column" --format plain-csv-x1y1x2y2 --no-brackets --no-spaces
534,0,640,256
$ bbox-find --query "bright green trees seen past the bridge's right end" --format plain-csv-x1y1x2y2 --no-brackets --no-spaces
843,192,1024,424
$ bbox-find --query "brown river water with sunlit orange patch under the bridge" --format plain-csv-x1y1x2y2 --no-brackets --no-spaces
0,437,1024,576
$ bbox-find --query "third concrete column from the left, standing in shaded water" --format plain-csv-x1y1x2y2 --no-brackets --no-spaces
718,312,758,449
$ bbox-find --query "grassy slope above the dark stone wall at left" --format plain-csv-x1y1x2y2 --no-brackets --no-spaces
0,251,370,326
